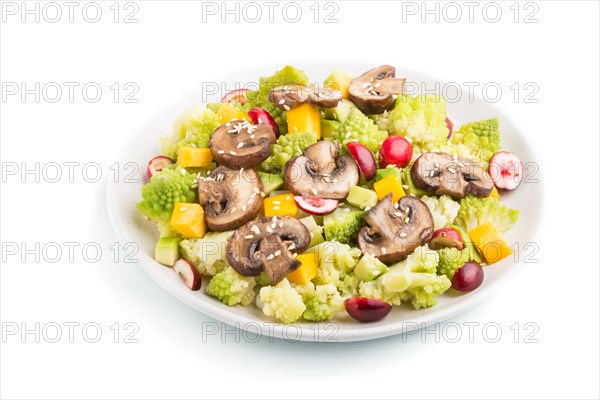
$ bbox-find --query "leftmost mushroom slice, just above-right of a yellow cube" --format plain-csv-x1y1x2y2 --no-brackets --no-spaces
198,166,262,232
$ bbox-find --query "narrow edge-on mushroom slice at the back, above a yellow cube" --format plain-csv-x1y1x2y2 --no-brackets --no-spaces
269,85,342,111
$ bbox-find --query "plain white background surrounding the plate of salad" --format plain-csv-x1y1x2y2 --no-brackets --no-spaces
0,1,600,398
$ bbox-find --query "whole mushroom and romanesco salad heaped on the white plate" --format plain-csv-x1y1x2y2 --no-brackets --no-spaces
137,65,523,324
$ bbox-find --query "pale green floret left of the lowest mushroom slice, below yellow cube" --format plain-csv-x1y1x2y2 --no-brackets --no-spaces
179,231,233,276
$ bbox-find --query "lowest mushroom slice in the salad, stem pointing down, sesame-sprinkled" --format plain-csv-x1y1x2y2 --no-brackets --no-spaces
227,216,310,285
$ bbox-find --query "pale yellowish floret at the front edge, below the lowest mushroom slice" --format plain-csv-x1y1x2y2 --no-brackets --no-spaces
256,279,306,324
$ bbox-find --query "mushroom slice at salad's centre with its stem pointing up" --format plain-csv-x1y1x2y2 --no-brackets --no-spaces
284,140,360,199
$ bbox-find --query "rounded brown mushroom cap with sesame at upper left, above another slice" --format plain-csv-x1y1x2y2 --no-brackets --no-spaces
208,120,277,169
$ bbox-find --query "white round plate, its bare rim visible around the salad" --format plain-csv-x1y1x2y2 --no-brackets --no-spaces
107,63,542,342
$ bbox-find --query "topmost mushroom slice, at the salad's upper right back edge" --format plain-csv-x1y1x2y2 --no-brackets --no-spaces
348,65,406,114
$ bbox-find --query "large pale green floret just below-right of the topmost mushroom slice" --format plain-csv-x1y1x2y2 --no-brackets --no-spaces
375,95,450,153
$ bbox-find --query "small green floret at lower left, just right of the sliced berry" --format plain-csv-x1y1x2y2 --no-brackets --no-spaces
206,267,256,307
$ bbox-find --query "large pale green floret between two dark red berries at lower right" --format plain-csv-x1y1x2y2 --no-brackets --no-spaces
359,245,451,310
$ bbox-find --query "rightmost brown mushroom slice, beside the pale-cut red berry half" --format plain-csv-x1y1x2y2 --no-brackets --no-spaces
410,152,494,198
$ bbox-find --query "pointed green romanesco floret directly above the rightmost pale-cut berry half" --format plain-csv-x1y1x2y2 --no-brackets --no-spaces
442,118,500,164
